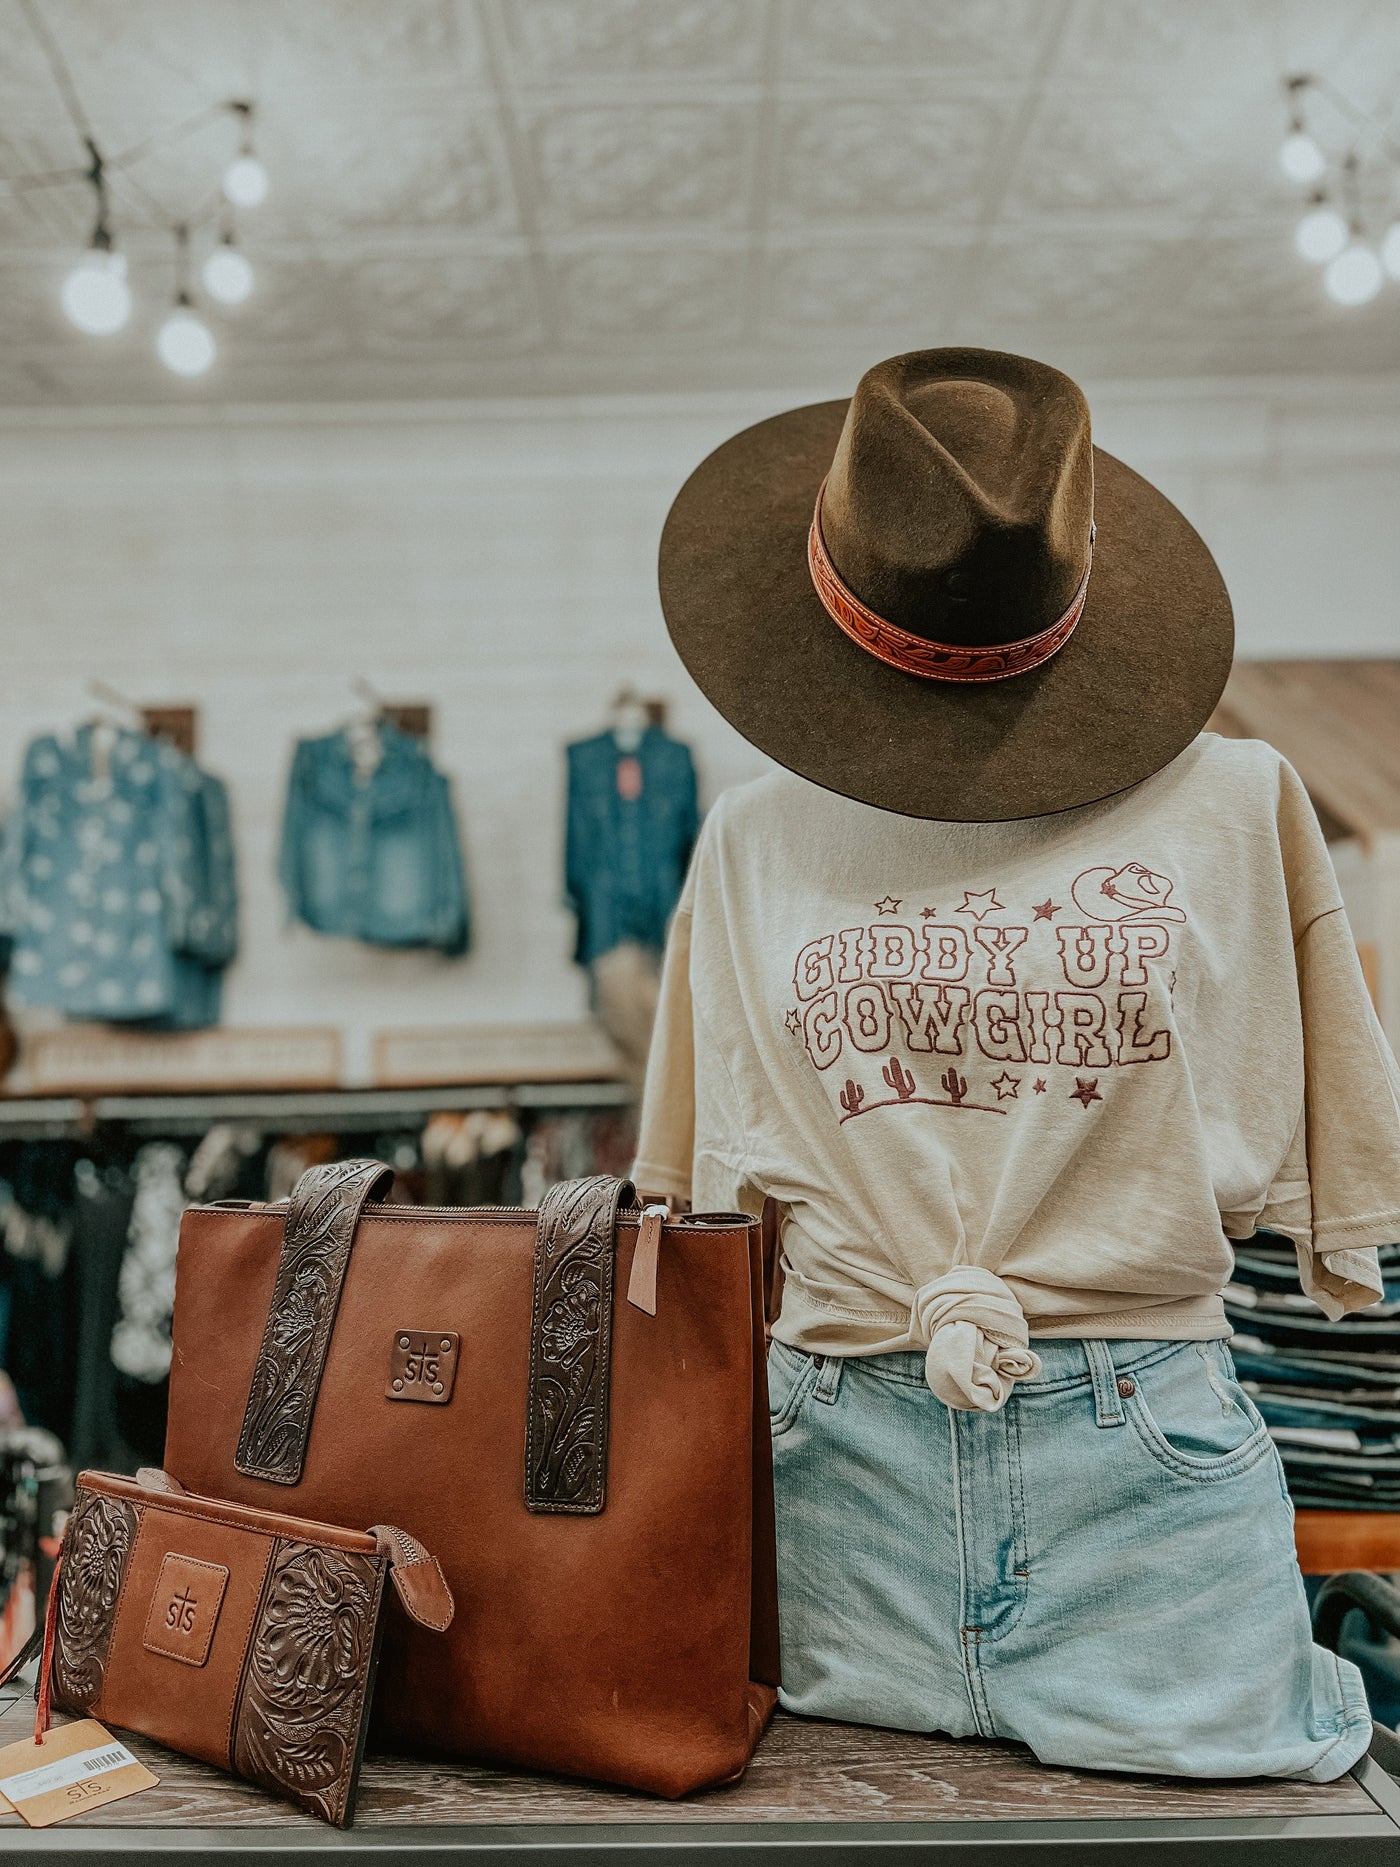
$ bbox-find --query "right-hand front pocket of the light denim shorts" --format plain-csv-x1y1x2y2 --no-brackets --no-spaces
1118,1342,1273,1482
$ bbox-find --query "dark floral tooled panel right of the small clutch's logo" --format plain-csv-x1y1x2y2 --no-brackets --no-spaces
233,1540,386,1826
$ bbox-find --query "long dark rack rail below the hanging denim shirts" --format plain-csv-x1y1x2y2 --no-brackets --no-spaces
0,1081,635,1141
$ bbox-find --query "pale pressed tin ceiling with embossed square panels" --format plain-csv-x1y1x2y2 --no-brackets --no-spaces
0,0,1400,405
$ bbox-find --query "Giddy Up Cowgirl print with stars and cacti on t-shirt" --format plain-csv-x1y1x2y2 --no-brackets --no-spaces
795,863,1187,1122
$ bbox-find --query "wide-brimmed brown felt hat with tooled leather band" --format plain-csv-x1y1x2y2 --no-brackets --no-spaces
661,349,1234,821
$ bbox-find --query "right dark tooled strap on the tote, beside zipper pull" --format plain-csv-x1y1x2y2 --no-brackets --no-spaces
525,1174,637,1516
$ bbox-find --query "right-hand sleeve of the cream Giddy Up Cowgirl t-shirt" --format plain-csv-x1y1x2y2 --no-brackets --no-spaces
1256,907,1400,1316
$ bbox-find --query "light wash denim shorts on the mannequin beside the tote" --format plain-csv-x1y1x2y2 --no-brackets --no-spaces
769,1341,1370,1783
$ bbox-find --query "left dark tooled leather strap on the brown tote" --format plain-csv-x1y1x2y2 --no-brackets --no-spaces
233,1161,394,1484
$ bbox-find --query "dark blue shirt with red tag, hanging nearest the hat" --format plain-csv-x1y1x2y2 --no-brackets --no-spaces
564,726,700,965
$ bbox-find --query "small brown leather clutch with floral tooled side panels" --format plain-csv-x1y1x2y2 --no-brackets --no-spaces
37,1471,454,1828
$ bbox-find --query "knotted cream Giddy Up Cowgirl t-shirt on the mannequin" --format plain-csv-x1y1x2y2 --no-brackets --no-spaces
635,734,1400,1408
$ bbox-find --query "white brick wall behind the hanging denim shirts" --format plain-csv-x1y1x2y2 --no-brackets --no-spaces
0,381,1400,1074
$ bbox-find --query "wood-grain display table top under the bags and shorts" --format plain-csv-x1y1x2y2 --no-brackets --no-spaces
0,1695,1400,1867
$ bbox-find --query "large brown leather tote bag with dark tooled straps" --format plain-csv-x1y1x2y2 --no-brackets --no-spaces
166,1161,778,1796
